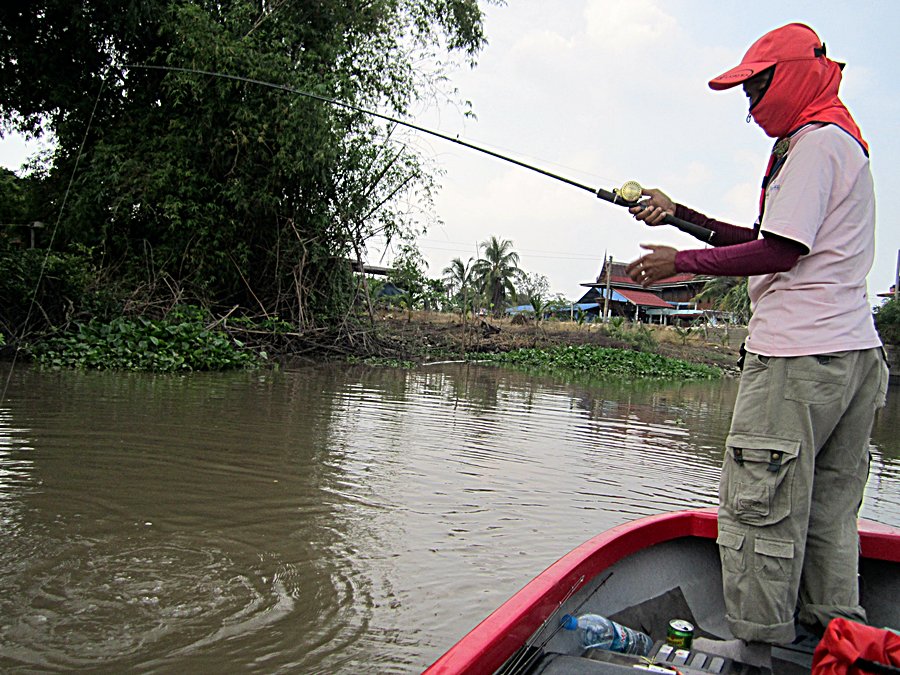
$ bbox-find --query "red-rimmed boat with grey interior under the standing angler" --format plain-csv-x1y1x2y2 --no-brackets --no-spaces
425,508,900,675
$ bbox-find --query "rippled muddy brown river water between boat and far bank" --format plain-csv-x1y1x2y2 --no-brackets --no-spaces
0,364,900,673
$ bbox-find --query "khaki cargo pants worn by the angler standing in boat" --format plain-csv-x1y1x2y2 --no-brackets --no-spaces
717,348,888,643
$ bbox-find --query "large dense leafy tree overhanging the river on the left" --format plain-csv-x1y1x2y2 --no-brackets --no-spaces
0,0,494,326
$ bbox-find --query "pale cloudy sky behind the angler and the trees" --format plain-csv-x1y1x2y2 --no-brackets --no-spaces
0,0,900,304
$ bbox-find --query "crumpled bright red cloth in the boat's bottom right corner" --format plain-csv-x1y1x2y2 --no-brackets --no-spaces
812,618,900,675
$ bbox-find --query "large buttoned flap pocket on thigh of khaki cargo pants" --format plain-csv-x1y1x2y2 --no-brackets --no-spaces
720,434,800,526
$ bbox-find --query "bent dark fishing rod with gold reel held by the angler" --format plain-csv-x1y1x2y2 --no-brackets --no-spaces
125,64,715,242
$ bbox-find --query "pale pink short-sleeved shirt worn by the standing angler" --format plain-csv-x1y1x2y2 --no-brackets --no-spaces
746,124,881,356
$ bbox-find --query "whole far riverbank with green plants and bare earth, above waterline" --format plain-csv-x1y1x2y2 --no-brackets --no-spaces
12,307,746,374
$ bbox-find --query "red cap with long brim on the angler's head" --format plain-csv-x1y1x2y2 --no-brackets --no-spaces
709,23,825,90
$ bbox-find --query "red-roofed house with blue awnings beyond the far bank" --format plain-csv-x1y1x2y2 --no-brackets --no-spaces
578,258,720,324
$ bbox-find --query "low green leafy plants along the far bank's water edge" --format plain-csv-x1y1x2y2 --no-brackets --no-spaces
27,305,722,380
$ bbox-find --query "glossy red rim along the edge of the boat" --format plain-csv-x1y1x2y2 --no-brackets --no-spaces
425,507,900,675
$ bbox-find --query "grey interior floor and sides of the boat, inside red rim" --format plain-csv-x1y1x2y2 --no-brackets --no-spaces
498,539,900,675
